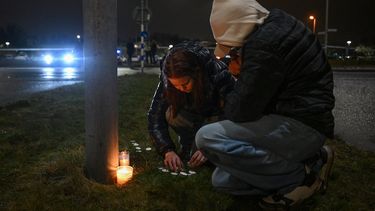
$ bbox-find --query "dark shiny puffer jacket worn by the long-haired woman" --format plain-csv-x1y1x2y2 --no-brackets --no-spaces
148,42,234,155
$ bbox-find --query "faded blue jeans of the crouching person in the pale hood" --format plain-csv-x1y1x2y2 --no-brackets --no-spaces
195,114,325,195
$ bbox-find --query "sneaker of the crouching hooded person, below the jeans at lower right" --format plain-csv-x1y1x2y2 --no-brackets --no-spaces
259,146,334,210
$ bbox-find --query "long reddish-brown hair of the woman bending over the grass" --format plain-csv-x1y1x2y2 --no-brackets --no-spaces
163,48,205,117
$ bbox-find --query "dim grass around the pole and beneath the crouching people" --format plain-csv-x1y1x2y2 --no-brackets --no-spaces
0,75,375,211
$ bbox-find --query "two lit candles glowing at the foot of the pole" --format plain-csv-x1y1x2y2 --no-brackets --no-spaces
117,150,133,185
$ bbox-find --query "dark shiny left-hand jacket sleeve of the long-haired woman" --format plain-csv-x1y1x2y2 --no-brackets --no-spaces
147,79,176,156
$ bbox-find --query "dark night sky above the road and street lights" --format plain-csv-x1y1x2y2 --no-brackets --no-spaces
0,0,375,45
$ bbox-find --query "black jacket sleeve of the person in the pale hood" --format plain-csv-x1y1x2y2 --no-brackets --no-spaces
224,44,284,122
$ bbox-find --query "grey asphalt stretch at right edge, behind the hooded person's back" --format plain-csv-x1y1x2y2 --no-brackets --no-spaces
334,71,375,151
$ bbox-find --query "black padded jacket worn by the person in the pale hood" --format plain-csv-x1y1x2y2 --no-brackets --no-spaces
225,9,334,137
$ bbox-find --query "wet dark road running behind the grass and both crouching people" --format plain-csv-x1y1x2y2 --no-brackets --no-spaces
0,68,375,151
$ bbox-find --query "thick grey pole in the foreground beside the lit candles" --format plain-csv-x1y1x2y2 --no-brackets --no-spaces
83,0,118,184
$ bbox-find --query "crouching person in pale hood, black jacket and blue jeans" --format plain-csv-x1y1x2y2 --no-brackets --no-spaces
196,0,335,209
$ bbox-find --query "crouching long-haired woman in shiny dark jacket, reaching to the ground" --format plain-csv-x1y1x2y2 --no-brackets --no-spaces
148,41,234,171
